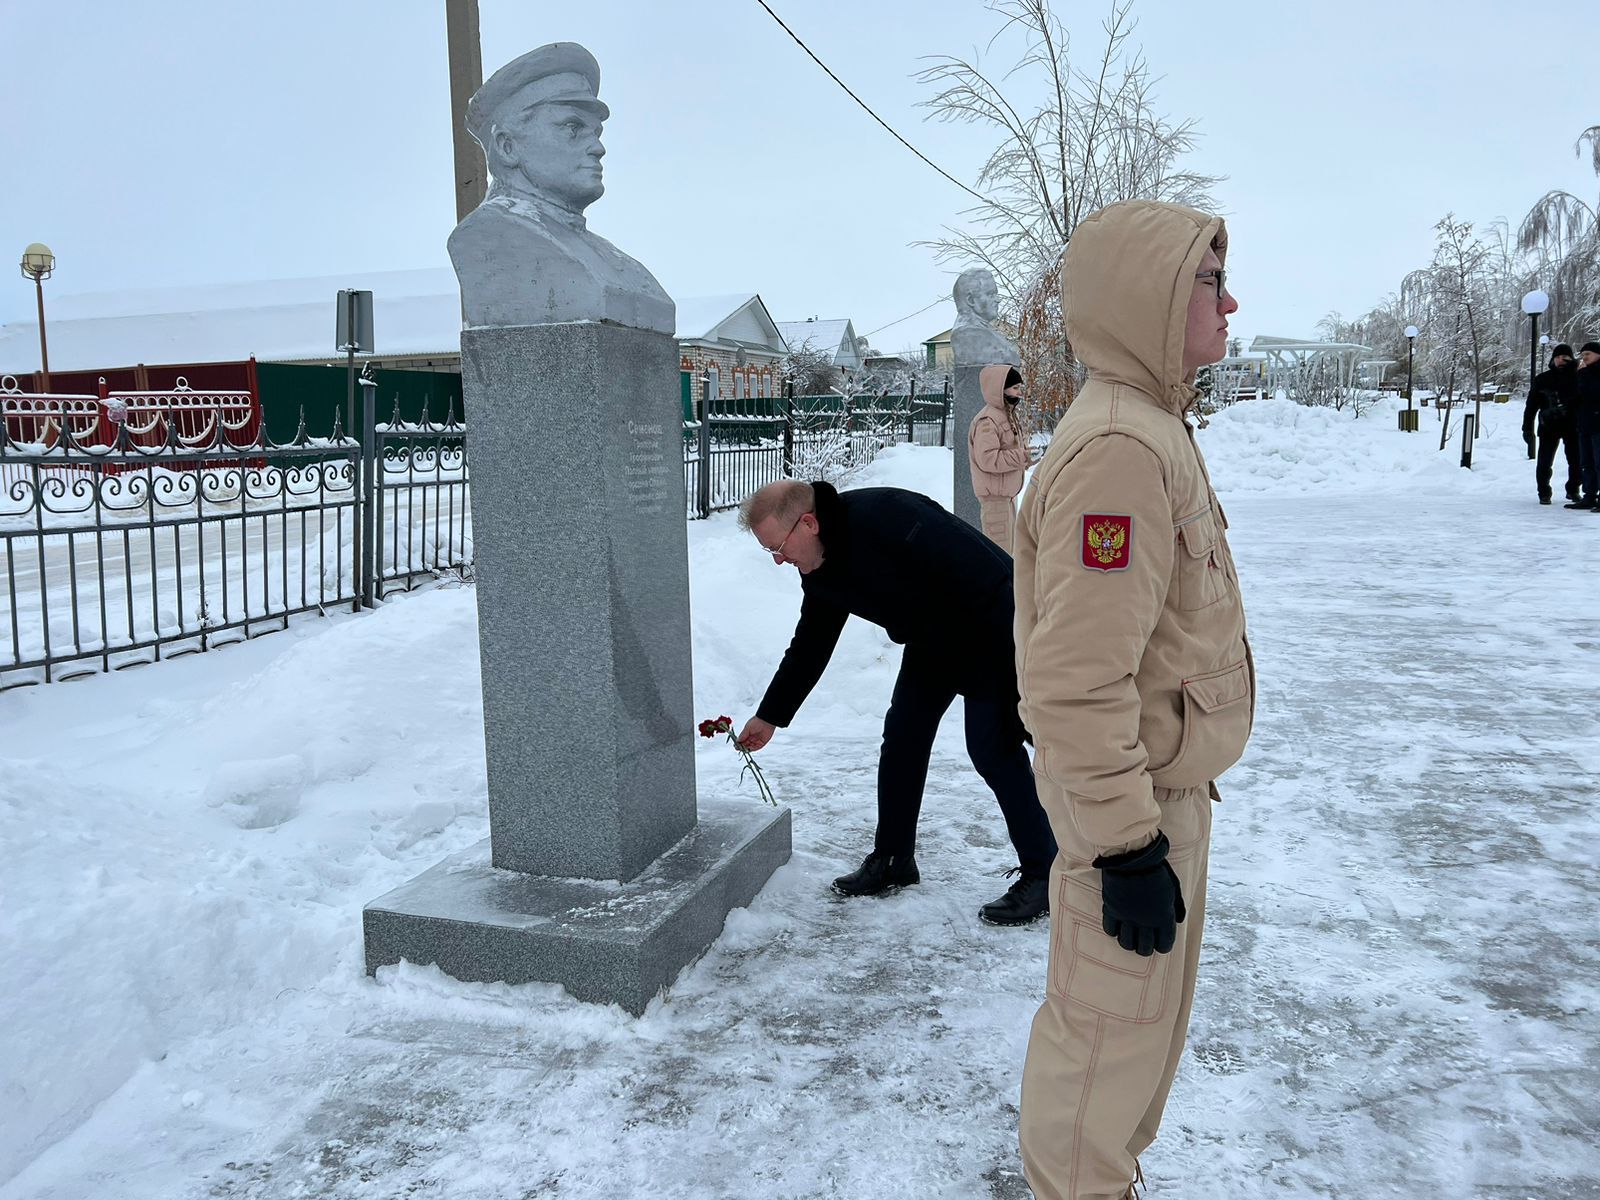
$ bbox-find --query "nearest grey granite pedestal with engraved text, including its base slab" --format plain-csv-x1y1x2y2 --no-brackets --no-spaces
365,322,790,1013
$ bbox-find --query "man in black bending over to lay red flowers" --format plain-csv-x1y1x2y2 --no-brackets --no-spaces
739,480,1056,925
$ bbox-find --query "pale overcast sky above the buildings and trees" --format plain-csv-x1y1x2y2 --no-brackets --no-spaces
0,0,1600,350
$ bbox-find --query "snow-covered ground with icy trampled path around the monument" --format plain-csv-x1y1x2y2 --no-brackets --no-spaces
0,400,1600,1200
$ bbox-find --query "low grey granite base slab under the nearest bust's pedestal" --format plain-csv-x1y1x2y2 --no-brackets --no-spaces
362,805,790,1016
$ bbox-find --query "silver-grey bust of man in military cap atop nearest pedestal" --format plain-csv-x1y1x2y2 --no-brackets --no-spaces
450,42,675,334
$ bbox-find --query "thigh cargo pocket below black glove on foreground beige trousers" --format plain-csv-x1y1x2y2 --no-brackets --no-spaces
1050,877,1182,1024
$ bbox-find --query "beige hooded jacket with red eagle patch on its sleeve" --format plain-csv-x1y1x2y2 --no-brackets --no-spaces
1014,202,1256,853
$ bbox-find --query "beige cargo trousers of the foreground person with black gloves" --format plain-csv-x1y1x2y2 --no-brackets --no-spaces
1021,787,1213,1200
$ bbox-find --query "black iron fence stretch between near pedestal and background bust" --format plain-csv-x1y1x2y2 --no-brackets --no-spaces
683,373,952,518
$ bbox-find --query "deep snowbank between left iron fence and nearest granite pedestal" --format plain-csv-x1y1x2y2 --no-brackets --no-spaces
0,589,488,1179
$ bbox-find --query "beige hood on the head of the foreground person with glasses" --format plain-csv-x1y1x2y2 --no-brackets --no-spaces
1061,200,1227,413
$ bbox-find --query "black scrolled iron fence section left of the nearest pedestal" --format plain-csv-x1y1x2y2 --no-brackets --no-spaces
0,381,472,690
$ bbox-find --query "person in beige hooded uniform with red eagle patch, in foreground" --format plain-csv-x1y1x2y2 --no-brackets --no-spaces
1016,200,1256,1200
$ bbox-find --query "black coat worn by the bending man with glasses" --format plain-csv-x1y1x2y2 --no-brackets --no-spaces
755,483,1016,726
